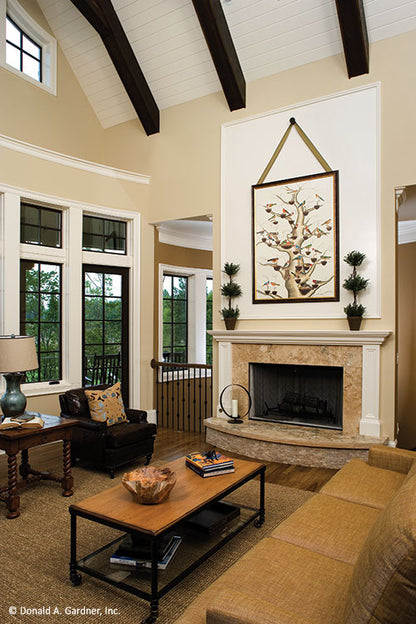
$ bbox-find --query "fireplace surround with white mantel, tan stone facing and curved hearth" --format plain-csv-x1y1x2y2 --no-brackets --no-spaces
206,330,391,467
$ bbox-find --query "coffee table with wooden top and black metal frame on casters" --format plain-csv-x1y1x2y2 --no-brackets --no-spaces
69,458,266,624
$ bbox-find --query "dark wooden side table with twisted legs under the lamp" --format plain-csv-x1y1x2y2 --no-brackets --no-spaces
0,414,78,518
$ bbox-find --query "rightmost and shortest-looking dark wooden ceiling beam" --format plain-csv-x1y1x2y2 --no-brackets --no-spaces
335,0,369,78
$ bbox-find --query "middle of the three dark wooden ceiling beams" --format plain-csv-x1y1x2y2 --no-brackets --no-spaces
192,0,246,110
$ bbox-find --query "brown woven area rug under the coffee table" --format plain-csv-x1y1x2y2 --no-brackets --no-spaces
0,468,313,624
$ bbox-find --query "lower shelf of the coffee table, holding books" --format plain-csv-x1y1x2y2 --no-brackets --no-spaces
71,506,260,624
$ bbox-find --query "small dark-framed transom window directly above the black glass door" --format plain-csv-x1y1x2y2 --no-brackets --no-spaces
82,215,127,254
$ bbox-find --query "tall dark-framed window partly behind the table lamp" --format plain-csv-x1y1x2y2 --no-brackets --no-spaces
20,260,62,382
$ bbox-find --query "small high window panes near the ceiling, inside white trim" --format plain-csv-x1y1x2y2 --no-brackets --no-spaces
6,15,42,82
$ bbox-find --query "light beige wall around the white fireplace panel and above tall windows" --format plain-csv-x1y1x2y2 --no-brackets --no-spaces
0,3,416,438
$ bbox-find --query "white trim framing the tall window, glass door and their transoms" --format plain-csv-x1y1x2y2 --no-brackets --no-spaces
0,185,140,407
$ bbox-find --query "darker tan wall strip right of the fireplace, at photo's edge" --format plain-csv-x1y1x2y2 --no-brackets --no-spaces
397,243,416,448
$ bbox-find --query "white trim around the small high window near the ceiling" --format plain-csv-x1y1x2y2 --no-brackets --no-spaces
0,0,57,95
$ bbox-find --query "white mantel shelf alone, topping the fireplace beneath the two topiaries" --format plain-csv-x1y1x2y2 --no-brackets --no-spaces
208,329,391,347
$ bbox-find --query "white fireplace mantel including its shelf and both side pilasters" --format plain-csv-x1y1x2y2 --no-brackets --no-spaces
209,329,391,437
